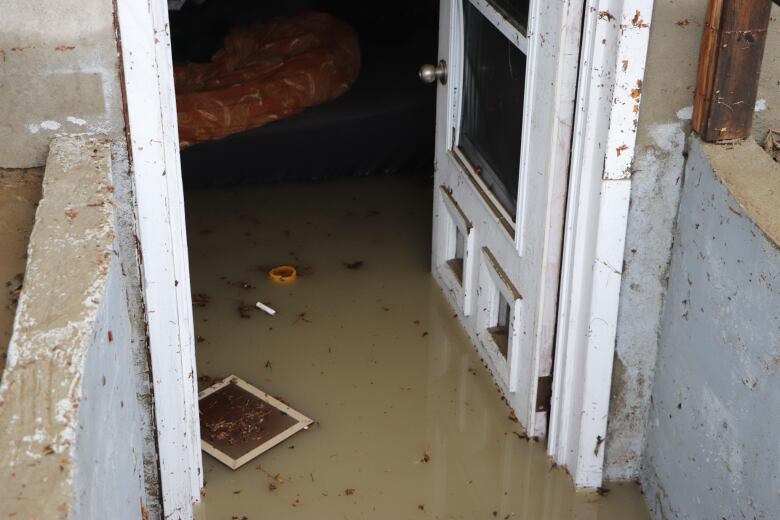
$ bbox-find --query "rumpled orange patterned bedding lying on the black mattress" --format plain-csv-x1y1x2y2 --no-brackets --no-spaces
174,12,360,148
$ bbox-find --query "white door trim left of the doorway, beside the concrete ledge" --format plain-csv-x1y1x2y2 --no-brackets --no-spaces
115,0,203,519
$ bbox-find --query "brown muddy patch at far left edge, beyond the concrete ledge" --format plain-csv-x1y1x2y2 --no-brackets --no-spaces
0,168,43,374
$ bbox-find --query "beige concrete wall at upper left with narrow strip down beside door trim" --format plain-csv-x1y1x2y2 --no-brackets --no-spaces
0,0,160,517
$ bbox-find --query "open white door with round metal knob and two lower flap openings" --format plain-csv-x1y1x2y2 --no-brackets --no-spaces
421,0,583,437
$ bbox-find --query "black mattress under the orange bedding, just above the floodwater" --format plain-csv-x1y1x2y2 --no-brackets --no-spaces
181,45,436,188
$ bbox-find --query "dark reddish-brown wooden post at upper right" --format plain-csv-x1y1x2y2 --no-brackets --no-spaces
693,0,772,142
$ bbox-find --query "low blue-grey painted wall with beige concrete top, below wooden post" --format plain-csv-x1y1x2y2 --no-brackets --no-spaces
642,139,780,519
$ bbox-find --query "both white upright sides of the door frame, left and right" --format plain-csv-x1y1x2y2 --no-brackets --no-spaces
122,0,653,504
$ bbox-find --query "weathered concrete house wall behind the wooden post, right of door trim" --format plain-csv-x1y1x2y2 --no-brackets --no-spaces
605,0,780,479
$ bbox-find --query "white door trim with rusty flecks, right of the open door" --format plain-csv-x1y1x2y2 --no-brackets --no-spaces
547,0,653,487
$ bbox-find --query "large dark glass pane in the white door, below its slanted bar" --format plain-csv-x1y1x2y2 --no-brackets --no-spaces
458,1,526,214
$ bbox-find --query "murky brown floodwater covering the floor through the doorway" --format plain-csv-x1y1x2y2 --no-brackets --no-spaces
186,176,648,520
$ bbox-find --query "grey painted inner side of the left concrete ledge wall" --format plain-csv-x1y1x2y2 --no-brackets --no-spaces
71,234,149,519
